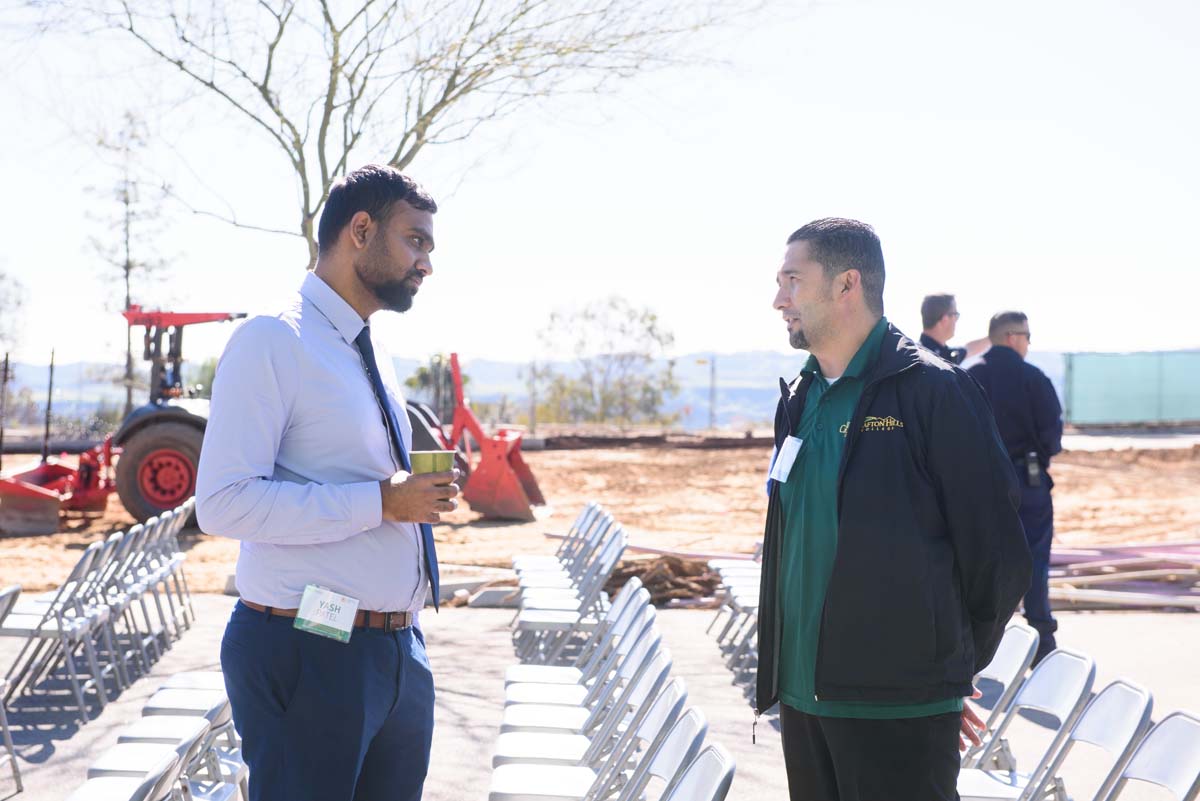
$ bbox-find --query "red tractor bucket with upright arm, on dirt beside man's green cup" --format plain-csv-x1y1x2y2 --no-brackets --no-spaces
450,354,546,520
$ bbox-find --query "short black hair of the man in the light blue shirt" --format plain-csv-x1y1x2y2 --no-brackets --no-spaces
317,164,438,253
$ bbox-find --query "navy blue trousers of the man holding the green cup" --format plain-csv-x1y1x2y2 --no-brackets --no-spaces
221,603,433,801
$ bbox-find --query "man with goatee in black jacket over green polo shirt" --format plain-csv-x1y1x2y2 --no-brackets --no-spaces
756,219,1030,801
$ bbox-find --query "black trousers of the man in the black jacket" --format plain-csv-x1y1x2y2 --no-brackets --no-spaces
779,704,962,801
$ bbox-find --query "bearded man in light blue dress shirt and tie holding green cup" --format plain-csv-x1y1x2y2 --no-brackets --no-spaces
196,165,458,801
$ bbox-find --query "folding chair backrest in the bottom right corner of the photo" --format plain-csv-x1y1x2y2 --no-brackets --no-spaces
1106,712,1200,801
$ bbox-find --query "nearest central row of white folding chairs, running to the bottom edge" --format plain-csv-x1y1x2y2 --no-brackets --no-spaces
488,577,734,801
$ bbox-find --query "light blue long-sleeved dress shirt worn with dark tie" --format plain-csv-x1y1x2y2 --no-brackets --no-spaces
196,272,428,612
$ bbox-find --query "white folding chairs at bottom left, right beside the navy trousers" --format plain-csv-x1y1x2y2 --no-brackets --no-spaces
67,670,250,801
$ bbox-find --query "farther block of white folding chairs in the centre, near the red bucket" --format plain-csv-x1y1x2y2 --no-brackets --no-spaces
512,504,629,664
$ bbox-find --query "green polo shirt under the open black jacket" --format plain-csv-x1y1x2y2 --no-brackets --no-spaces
779,319,962,719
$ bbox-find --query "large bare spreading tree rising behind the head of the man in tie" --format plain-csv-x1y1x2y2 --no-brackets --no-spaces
29,0,752,267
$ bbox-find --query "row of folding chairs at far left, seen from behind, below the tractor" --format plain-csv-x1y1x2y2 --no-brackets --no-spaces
0,499,196,723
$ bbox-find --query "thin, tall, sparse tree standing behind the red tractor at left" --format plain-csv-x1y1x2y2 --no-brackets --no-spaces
91,112,169,415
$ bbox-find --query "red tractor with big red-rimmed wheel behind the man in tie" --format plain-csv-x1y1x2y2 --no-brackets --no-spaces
113,306,246,520
